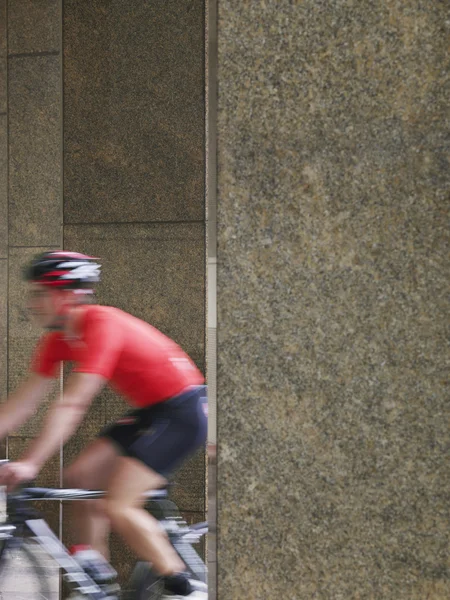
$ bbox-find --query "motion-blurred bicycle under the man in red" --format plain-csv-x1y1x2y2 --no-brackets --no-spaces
0,461,208,600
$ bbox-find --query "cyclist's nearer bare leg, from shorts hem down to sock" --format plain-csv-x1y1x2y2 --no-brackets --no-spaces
103,457,185,575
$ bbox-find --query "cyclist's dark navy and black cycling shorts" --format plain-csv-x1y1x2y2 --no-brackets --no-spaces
99,386,208,476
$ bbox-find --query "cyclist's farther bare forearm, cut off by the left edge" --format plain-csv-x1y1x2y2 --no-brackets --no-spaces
0,373,52,439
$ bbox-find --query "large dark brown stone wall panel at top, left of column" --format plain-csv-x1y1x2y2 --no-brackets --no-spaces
64,0,205,223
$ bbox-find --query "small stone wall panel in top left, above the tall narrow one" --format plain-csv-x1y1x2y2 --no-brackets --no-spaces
8,0,61,54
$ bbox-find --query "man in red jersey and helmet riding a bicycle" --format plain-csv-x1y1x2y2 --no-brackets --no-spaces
0,251,207,599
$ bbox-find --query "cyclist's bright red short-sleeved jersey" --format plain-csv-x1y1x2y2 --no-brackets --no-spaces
32,305,204,407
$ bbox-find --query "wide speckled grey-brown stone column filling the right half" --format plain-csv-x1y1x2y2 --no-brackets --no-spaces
217,0,450,600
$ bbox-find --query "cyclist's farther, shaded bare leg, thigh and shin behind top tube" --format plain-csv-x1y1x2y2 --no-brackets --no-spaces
64,438,119,559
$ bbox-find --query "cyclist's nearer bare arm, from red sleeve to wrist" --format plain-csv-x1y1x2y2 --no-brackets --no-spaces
22,373,107,468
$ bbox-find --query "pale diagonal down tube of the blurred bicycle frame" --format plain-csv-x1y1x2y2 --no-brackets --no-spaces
25,519,109,600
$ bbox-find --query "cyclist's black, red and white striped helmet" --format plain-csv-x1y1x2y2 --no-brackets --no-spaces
25,250,100,291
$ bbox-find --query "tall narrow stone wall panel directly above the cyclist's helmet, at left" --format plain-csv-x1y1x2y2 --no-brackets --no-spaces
8,56,62,246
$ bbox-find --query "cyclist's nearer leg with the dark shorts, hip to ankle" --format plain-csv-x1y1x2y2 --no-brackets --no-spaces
105,387,207,575
